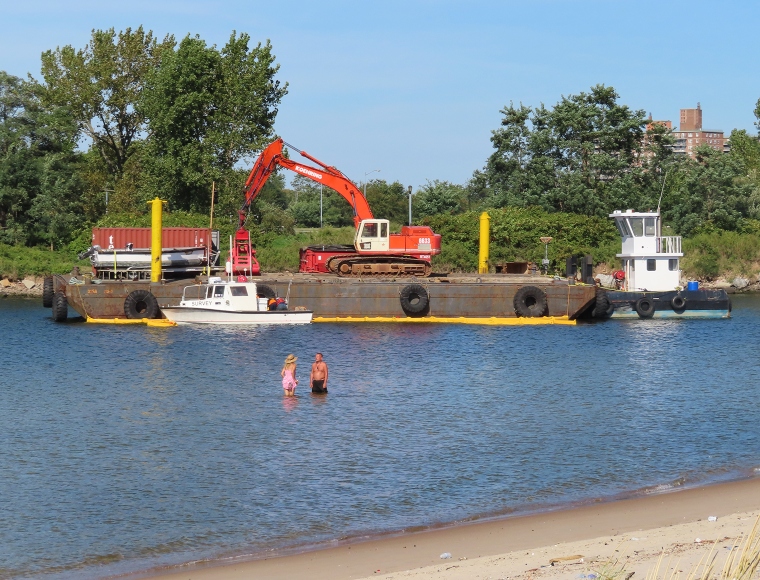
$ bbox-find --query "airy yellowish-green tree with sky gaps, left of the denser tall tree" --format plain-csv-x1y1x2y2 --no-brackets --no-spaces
40,26,175,181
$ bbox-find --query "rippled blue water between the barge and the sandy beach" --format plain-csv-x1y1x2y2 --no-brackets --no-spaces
0,296,760,579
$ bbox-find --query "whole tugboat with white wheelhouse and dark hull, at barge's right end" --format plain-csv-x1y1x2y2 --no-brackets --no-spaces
606,209,731,319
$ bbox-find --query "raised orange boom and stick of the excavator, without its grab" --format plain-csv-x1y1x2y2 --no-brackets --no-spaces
238,139,373,228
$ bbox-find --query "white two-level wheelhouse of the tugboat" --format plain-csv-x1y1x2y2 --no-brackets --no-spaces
610,209,683,292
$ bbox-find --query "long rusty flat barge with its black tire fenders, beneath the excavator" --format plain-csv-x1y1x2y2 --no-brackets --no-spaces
43,274,603,322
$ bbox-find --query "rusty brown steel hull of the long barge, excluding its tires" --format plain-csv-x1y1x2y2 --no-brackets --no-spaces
54,274,596,320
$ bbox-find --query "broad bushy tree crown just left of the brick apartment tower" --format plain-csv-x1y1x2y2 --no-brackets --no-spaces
476,85,646,216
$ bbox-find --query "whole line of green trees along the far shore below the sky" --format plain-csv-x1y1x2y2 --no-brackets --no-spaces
0,27,760,250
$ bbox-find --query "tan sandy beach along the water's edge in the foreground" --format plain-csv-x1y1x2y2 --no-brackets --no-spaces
141,478,760,580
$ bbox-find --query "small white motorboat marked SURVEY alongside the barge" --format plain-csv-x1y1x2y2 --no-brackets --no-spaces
161,276,313,324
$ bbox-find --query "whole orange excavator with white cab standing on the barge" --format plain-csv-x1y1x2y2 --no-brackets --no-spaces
231,139,441,276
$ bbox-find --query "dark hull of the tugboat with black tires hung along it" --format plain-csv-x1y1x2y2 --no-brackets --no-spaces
607,288,731,320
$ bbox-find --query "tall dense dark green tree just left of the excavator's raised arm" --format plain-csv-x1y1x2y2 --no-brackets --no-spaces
139,32,287,209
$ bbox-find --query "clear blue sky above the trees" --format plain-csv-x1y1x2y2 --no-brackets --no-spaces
0,0,760,189
